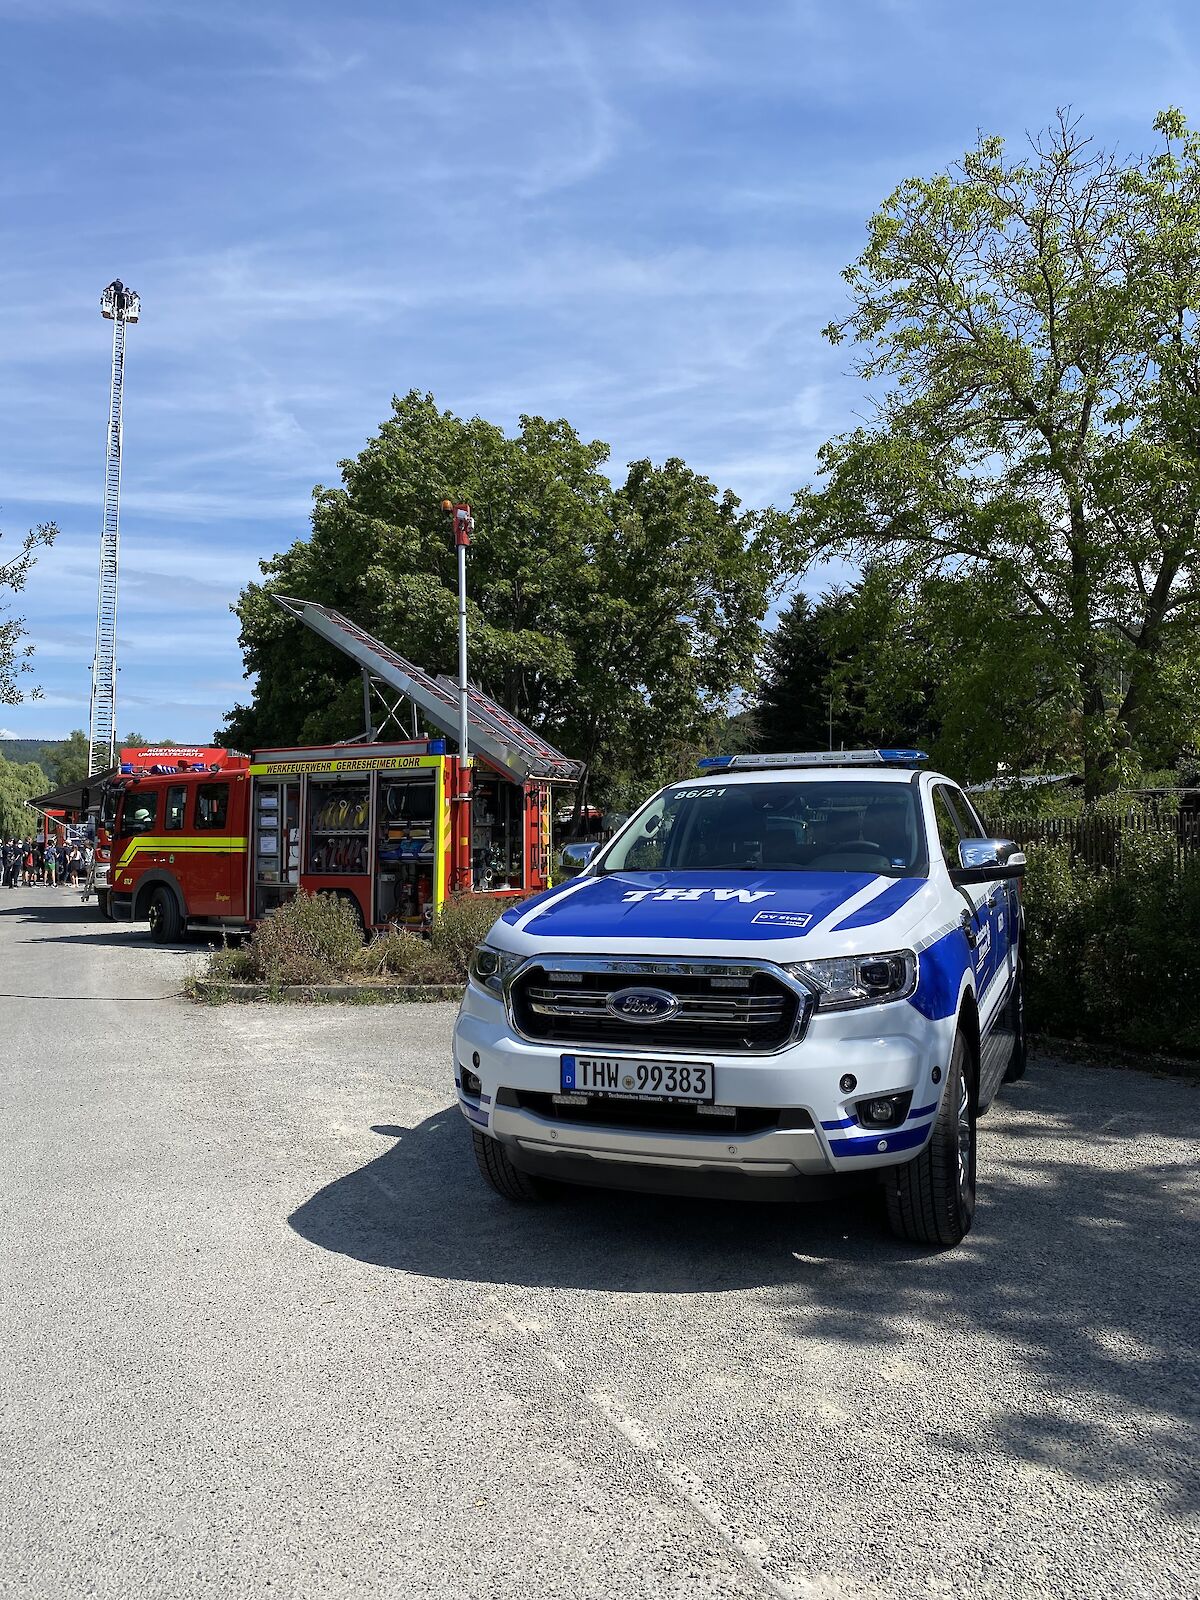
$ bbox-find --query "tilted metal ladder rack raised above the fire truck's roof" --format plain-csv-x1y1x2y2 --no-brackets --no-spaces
270,592,582,782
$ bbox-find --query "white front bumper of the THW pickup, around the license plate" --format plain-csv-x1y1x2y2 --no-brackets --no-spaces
454,984,954,1190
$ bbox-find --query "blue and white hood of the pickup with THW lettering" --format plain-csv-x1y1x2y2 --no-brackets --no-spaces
493,872,936,962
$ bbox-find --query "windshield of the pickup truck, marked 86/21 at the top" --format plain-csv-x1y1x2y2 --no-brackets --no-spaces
598,779,926,877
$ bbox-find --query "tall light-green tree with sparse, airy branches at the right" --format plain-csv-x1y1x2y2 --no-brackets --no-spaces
797,112,1200,797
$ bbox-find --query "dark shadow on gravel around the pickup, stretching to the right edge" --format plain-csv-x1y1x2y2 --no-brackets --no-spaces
290,1069,1200,1510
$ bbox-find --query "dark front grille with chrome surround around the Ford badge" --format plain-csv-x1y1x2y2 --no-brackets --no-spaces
509,955,811,1054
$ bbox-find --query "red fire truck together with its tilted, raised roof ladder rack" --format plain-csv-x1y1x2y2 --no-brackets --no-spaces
104,600,579,941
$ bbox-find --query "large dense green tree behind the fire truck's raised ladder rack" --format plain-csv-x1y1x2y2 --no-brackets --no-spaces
216,392,782,803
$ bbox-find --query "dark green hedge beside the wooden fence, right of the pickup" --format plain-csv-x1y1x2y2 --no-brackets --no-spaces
1024,832,1200,1054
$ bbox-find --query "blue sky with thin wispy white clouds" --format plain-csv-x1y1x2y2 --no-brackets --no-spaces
0,0,1200,741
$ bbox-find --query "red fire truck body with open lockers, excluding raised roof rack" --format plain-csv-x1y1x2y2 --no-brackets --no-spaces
109,739,566,941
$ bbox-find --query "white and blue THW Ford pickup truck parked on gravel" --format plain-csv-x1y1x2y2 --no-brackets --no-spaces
454,750,1026,1246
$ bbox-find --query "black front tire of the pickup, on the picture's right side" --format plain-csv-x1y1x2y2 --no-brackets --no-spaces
883,1030,976,1250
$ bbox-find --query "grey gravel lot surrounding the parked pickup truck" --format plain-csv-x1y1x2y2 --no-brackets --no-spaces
0,890,1200,1600
